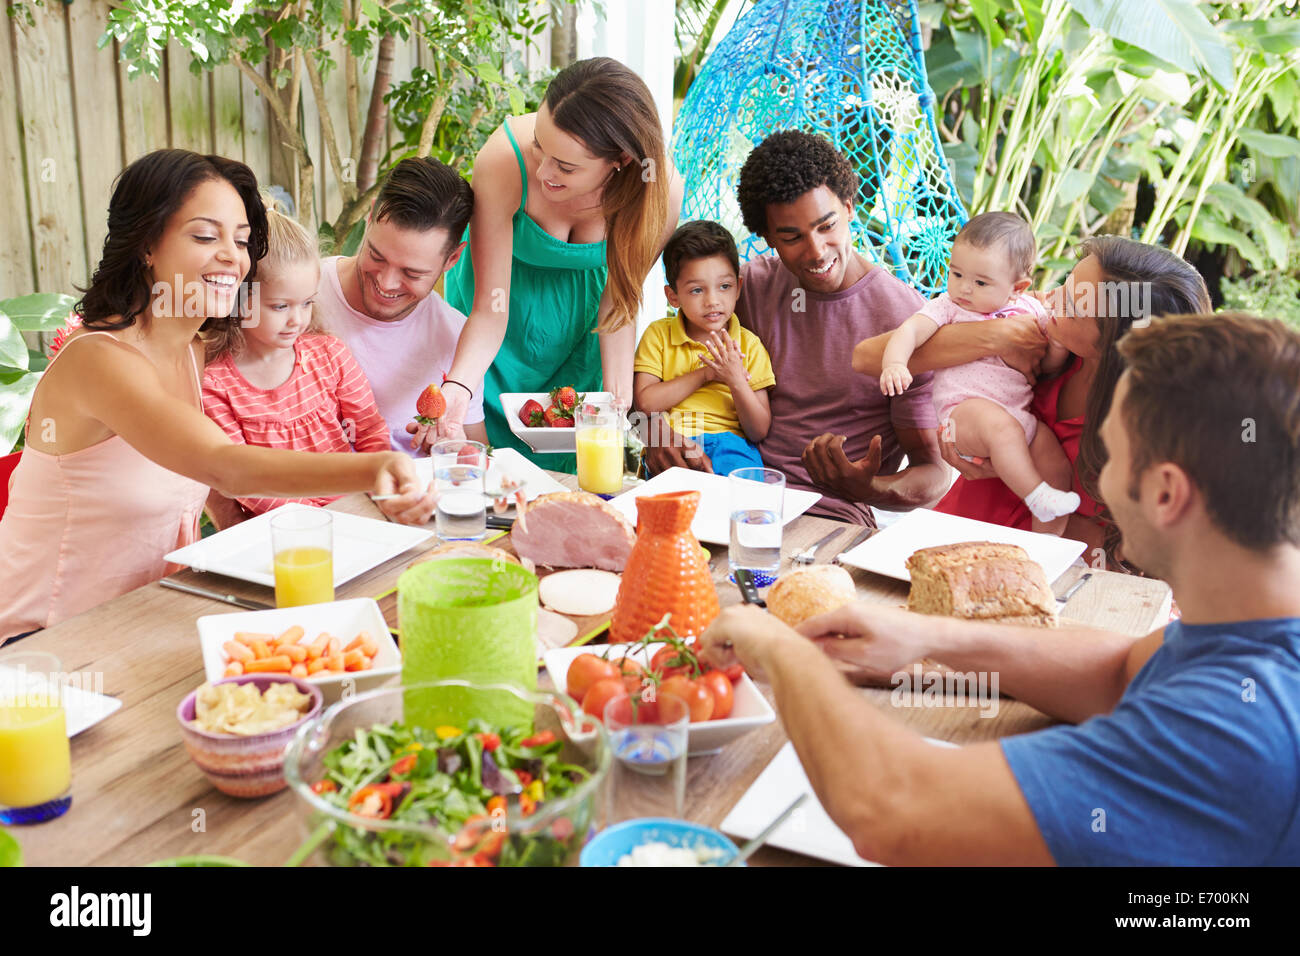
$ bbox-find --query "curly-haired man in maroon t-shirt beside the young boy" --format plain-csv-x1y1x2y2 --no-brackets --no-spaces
649,130,949,525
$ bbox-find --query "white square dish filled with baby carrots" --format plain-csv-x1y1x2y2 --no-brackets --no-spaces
198,597,402,704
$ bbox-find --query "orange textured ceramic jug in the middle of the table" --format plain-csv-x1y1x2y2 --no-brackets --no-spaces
610,492,718,643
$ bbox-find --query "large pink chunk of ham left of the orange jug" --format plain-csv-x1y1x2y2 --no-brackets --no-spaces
510,492,637,571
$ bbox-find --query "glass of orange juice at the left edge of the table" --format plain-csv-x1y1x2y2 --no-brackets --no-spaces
0,652,73,823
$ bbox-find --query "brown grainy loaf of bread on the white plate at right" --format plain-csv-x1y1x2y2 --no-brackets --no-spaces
907,541,1057,627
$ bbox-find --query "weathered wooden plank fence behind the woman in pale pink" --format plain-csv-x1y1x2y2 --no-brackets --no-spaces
0,0,550,298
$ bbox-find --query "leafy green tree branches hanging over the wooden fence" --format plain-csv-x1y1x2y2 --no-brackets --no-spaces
100,0,575,243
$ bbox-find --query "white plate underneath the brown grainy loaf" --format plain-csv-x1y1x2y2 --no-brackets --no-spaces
840,509,1087,584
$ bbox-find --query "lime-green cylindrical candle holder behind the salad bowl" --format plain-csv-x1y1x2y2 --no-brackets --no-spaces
398,558,537,730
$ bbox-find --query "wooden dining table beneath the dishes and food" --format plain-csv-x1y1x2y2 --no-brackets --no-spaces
10,473,1170,866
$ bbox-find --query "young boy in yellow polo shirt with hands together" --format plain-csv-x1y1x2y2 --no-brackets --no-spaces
632,220,776,475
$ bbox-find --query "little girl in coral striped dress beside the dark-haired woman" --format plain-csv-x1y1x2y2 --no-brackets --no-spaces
203,208,390,527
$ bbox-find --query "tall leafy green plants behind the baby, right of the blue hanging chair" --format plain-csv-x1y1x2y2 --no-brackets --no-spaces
920,0,1300,286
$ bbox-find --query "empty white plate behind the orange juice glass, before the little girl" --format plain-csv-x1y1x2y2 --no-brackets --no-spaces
165,505,433,588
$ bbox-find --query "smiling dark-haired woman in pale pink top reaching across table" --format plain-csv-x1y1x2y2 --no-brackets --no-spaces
0,150,433,640
